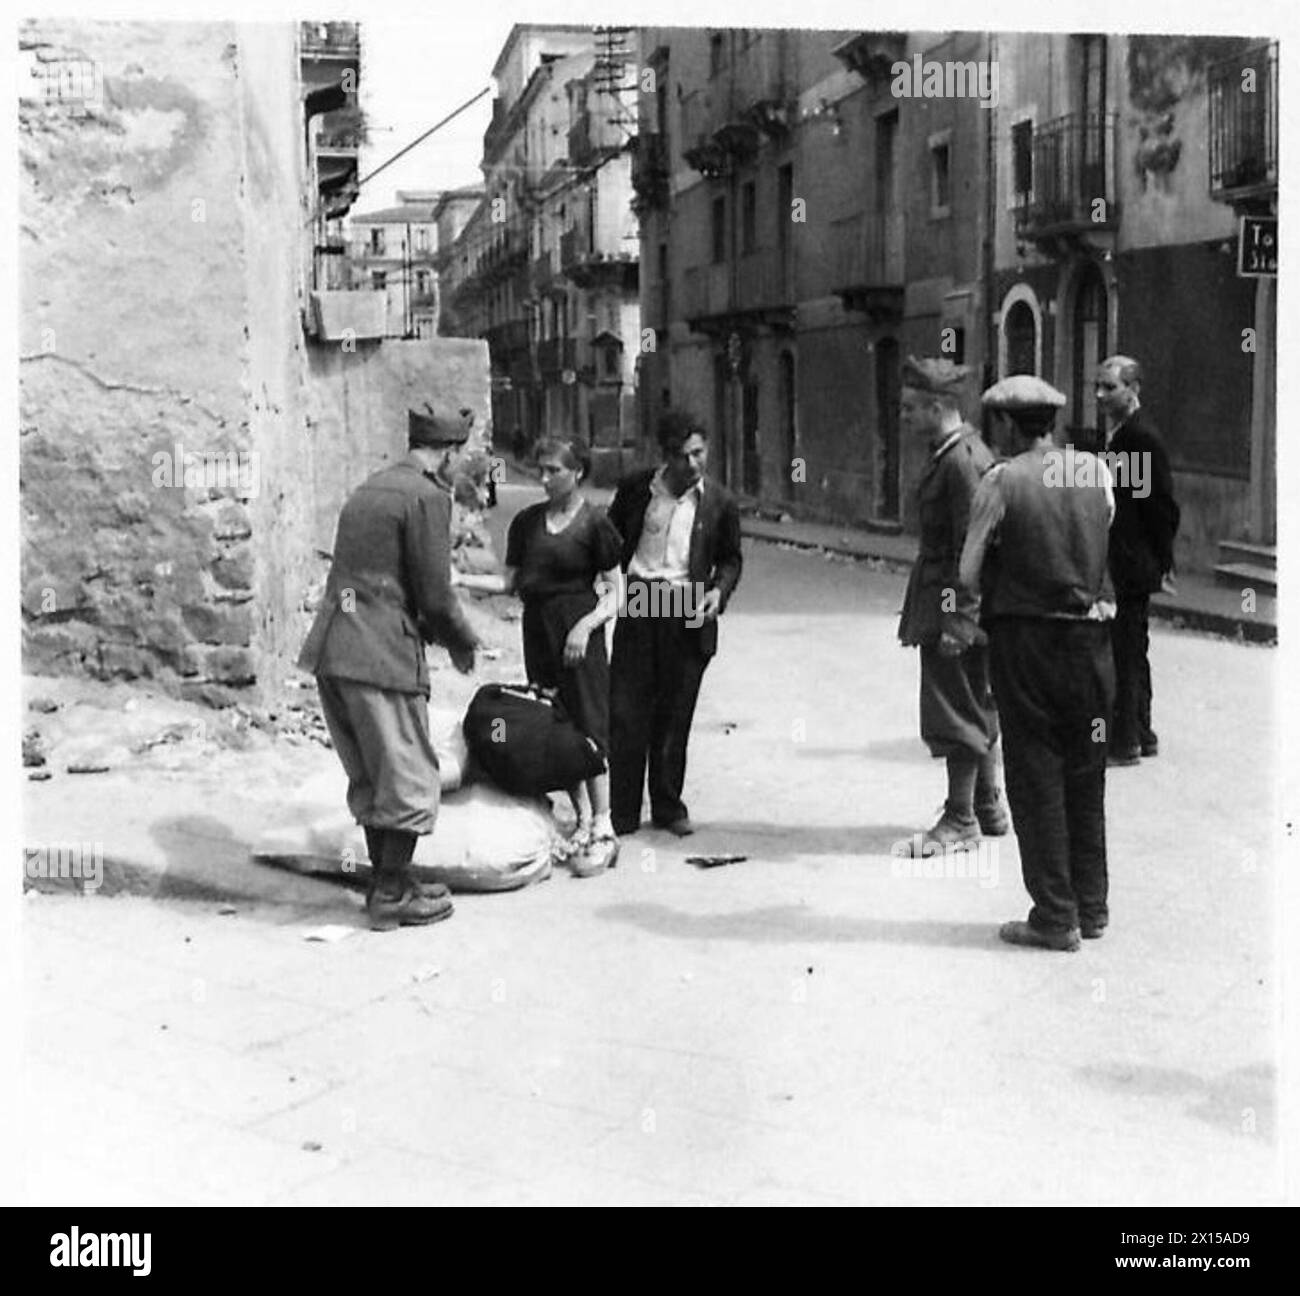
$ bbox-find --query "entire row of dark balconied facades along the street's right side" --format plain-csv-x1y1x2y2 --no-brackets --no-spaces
633,29,1277,576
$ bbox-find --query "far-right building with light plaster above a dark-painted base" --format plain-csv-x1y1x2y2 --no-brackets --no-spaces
989,32,1278,584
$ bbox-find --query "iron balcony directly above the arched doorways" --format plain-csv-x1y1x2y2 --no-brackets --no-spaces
1017,112,1119,238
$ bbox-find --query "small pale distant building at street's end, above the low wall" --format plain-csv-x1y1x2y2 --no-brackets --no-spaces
348,194,438,338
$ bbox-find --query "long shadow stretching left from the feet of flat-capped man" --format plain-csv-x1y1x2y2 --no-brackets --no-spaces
595,905,1006,950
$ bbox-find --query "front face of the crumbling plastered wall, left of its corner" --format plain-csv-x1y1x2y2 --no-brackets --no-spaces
20,19,270,695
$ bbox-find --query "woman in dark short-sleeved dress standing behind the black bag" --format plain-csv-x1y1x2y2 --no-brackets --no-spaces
459,438,623,877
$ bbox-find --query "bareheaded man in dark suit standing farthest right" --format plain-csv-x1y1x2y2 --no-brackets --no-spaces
1097,355,1179,766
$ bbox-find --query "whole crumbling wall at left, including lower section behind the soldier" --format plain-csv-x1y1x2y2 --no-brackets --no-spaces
20,19,489,705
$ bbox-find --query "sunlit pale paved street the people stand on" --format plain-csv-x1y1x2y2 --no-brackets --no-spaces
15,487,1282,1204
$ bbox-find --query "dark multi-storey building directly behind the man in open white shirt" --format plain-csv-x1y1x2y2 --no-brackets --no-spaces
634,29,985,530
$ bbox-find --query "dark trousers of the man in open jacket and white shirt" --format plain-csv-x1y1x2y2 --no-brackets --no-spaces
610,577,710,831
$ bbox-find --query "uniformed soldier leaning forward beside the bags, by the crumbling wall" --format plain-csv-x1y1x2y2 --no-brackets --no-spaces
298,409,478,931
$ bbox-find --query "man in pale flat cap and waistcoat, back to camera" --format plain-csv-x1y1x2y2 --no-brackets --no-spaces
958,374,1115,950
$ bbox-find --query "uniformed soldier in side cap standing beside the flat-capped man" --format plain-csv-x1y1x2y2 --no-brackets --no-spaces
898,356,1009,854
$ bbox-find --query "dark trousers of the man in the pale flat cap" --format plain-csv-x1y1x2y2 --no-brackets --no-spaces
989,617,1115,932
